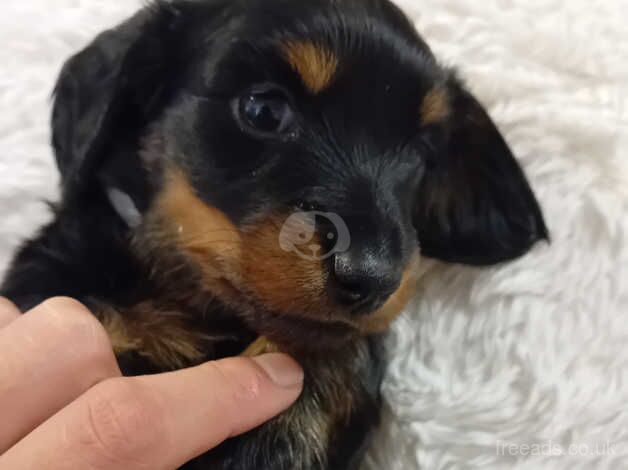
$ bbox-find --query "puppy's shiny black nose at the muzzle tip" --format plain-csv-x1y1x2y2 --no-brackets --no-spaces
329,250,401,315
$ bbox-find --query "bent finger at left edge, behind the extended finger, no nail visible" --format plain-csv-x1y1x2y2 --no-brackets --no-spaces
0,299,120,453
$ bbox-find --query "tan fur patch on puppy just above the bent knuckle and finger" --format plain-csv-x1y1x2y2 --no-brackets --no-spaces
96,302,209,370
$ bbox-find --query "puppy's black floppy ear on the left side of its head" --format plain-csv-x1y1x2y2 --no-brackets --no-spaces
52,2,184,202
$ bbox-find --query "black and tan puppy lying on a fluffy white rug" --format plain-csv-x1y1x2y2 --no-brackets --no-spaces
2,0,547,470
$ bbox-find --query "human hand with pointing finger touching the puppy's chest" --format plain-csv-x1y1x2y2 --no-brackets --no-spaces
0,298,303,470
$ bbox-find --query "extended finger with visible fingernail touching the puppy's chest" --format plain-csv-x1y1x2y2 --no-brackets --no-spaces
0,354,303,470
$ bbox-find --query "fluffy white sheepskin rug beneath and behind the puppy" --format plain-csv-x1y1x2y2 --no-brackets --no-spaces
0,0,628,470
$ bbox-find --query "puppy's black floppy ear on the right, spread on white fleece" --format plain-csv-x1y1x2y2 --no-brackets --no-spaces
415,79,548,265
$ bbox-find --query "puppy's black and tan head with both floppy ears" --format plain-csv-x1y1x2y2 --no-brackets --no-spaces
53,0,547,346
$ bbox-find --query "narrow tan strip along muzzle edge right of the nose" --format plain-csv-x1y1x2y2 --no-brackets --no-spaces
361,254,420,333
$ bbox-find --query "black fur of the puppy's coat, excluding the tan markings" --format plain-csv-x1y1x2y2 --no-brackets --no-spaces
1,0,547,470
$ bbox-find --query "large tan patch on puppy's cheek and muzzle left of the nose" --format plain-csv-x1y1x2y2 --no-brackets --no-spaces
149,169,326,315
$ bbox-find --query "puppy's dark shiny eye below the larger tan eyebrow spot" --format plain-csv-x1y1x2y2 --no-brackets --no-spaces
237,89,294,136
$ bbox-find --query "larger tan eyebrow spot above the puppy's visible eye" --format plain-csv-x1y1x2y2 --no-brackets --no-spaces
283,42,338,94
